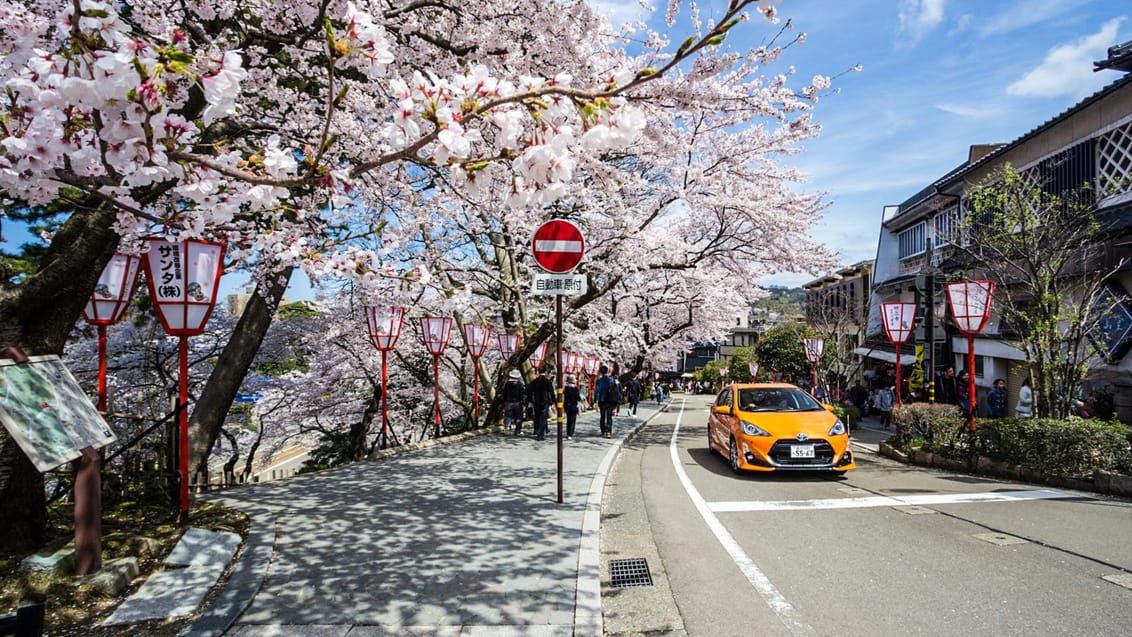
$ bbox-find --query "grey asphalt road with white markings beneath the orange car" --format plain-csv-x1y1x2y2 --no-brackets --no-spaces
602,397,1132,637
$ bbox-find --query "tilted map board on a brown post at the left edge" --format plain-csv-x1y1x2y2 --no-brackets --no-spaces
0,356,117,472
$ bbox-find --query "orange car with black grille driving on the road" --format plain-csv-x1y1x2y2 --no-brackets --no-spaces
708,382,857,473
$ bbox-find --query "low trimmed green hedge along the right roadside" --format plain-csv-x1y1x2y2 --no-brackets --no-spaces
892,403,1132,476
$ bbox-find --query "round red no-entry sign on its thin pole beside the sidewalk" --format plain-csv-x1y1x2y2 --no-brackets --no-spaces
531,219,585,503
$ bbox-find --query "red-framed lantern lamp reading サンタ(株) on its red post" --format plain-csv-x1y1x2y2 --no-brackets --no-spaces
142,236,224,524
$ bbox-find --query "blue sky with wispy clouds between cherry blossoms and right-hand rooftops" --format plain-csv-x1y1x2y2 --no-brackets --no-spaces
591,0,1132,285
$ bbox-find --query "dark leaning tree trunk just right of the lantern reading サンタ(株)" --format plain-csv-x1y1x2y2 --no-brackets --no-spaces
189,268,294,484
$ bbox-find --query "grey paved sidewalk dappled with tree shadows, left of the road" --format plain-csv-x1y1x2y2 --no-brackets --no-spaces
186,402,659,637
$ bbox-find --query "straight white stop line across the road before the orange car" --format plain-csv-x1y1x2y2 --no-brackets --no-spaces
708,489,1077,513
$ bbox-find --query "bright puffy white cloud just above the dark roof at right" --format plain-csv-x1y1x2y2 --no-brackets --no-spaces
1006,17,1124,98
